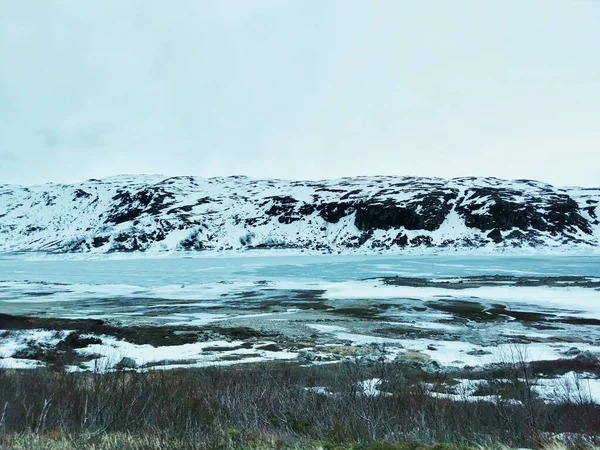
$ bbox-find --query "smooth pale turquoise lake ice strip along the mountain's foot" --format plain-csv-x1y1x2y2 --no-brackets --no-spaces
0,255,600,288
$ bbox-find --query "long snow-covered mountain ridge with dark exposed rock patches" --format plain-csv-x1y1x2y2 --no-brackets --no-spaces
0,175,600,253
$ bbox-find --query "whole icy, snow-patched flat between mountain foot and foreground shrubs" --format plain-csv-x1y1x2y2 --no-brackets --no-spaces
0,252,600,401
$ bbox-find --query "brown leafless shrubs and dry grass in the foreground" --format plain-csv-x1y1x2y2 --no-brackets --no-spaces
0,363,600,450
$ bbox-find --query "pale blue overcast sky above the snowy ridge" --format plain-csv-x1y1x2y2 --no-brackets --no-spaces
0,0,600,186
